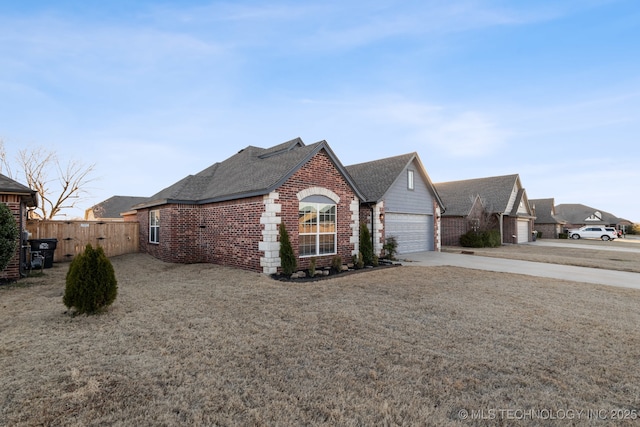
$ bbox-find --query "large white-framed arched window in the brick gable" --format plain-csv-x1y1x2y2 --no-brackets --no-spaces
298,195,337,257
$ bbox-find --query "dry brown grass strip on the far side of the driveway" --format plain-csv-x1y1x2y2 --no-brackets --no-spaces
443,239,640,273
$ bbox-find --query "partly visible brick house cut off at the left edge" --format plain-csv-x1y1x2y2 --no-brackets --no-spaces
0,174,38,280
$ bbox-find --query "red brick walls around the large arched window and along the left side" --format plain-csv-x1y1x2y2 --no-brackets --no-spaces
137,151,357,271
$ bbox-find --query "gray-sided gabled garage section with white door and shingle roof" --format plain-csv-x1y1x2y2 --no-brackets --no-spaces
347,153,443,254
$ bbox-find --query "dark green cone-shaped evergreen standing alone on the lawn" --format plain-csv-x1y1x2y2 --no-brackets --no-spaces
62,244,118,314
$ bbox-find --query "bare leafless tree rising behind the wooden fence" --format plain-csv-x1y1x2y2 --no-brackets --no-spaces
0,141,95,219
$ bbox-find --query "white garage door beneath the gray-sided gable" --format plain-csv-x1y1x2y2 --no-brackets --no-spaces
384,212,433,254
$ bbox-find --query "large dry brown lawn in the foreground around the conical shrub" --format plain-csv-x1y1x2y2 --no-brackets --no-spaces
0,254,640,426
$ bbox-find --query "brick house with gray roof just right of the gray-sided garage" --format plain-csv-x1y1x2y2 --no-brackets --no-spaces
435,174,534,246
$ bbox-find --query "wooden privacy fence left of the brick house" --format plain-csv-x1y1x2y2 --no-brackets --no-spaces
27,220,139,262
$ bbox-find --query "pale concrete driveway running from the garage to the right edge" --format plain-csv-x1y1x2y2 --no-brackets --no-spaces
398,248,640,289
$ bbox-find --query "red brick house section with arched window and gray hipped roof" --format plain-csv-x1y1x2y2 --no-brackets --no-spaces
125,138,363,274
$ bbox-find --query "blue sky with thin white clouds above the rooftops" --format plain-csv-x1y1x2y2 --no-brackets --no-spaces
0,0,640,222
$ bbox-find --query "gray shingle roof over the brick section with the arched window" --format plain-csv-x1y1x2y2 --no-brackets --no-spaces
135,138,361,208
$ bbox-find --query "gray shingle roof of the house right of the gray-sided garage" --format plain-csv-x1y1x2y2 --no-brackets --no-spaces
435,174,520,216
